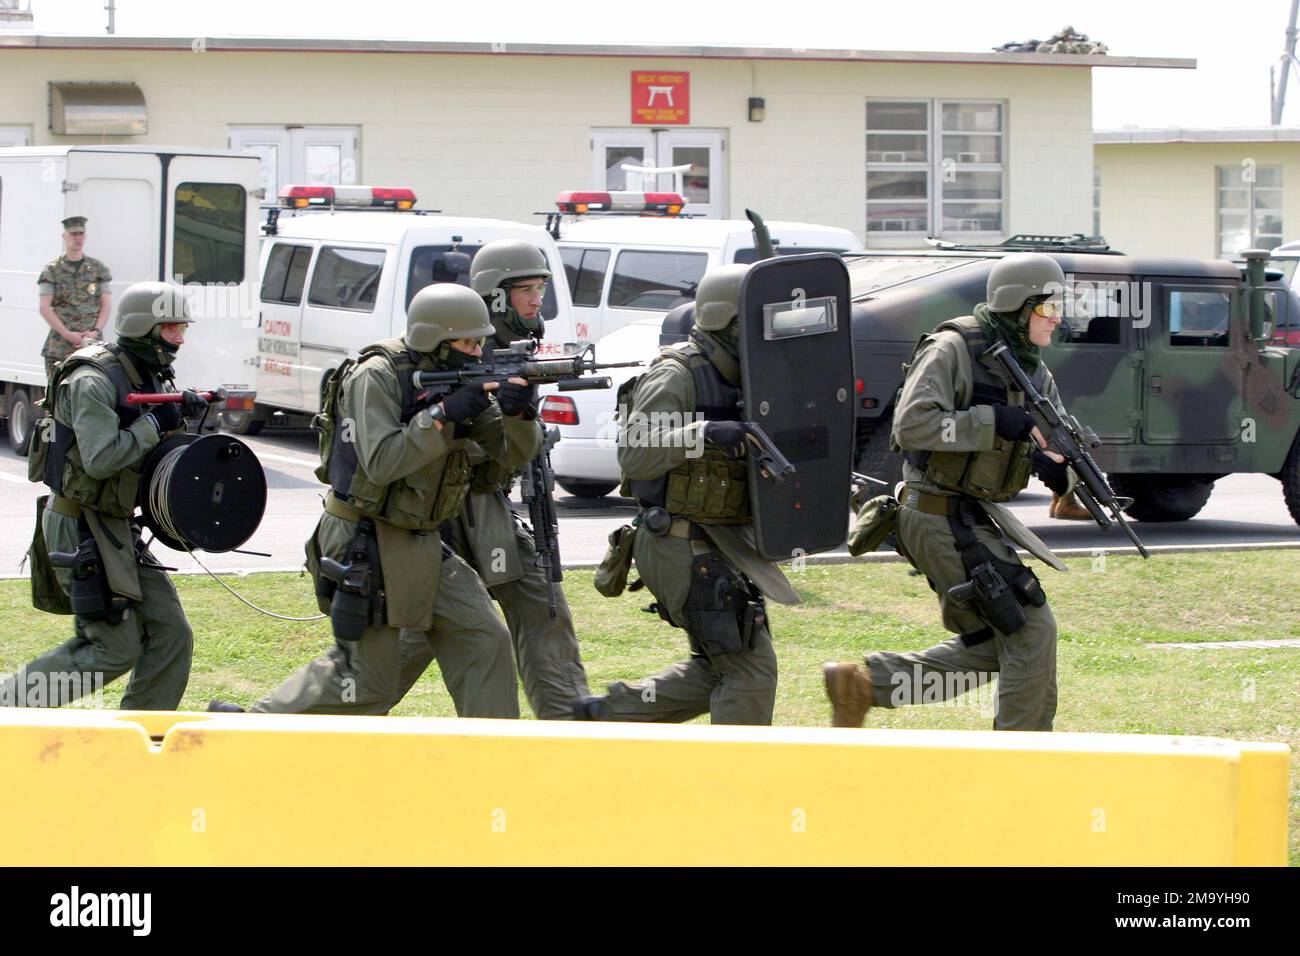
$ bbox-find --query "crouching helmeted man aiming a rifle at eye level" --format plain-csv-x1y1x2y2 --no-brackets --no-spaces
208,284,541,717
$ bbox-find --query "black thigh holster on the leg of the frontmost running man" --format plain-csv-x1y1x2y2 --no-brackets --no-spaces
948,496,1048,646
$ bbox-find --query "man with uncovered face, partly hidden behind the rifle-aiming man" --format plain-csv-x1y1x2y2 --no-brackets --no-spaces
387,239,589,721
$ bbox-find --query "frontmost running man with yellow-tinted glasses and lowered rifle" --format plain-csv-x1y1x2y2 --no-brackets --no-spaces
824,254,1070,730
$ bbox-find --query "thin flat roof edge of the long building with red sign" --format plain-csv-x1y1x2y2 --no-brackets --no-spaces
0,34,1196,70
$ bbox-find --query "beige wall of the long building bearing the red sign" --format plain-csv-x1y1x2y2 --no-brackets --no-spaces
0,49,1093,244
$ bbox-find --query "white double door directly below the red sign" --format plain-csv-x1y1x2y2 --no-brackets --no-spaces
592,129,727,219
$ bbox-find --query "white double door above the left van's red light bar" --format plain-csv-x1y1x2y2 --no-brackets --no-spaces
230,126,360,203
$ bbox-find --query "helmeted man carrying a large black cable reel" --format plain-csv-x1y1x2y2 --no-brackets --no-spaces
0,282,207,710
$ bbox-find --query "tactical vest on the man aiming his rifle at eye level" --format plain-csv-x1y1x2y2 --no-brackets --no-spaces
325,338,471,531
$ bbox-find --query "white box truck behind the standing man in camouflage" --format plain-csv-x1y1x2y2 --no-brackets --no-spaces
0,146,260,454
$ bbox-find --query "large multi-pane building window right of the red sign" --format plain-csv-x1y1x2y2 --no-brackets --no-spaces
867,100,1006,238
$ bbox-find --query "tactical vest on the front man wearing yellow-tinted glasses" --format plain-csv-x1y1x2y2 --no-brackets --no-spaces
904,316,1048,501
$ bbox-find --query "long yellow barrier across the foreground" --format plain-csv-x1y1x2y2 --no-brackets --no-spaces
0,709,1288,866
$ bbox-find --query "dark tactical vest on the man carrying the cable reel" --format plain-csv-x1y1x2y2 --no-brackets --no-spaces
36,343,159,518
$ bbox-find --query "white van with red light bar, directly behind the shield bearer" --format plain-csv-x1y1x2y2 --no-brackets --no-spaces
556,193,861,343
